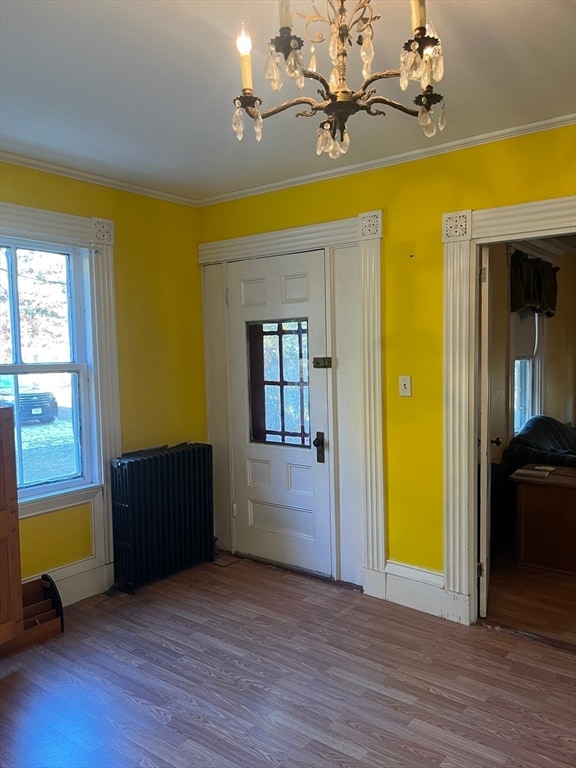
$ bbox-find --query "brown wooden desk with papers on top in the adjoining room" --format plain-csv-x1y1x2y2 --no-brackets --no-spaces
510,464,576,574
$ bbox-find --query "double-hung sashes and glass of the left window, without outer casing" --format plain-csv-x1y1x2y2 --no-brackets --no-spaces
0,238,94,498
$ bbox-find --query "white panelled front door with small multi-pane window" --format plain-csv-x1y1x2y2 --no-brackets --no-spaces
227,250,332,575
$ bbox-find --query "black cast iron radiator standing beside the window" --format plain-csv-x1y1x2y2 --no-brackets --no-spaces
111,443,214,591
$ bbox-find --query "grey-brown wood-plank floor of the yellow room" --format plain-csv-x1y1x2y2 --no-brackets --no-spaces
0,560,576,768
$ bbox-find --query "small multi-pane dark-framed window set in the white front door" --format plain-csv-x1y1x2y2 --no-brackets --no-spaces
247,319,310,448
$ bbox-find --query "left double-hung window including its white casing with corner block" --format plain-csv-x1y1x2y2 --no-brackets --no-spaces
0,204,119,502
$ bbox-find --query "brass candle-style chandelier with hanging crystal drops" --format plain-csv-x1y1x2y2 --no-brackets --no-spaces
232,0,446,158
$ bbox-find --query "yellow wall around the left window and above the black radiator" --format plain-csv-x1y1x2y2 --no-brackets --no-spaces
0,164,206,576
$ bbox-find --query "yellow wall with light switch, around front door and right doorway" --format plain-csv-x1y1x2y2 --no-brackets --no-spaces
198,126,576,570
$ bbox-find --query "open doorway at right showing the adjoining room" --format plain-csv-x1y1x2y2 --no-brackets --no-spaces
480,235,576,649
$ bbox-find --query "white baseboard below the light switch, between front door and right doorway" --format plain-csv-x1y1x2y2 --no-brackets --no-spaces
363,561,472,624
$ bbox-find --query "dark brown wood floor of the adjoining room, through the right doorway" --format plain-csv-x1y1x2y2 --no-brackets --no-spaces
487,556,576,651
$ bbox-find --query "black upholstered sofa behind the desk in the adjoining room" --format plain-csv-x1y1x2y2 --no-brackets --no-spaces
502,415,576,471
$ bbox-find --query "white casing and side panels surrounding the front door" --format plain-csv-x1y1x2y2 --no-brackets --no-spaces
199,211,386,597
